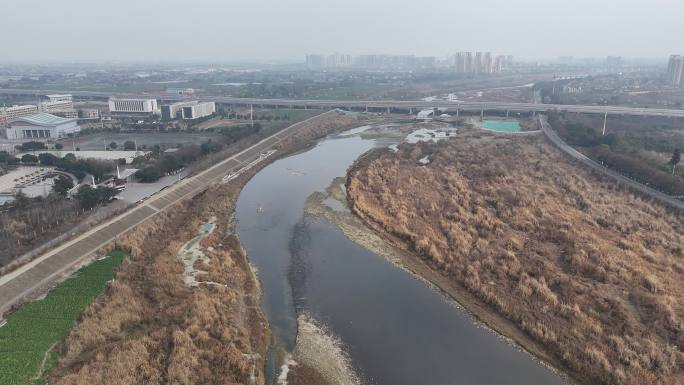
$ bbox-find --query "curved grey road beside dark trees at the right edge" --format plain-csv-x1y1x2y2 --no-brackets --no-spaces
539,116,684,211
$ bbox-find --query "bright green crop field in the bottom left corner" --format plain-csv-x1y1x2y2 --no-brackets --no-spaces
0,251,126,385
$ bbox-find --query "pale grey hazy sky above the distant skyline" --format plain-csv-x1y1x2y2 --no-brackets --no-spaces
0,0,684,62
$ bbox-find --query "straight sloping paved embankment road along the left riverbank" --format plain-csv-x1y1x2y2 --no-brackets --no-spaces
0,111,336,315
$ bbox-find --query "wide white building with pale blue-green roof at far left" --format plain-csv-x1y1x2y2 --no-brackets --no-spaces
6,112,81,140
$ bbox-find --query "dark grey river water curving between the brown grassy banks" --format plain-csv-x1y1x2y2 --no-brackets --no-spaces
236,128,564,385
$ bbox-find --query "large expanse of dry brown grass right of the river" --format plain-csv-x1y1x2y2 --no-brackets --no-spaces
347,131,684,385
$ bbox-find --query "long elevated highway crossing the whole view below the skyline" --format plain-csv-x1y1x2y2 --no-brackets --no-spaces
0,89,684,117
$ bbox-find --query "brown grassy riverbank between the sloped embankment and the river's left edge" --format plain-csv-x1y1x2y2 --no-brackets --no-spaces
20,109,368,385
